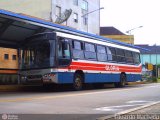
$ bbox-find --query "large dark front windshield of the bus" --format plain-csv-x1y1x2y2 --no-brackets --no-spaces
21,40,55,69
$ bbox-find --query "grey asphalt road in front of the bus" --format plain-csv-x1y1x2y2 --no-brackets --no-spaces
0,83,160,120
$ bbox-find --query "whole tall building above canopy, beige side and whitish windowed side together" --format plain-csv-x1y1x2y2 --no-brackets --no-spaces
0,0,100,35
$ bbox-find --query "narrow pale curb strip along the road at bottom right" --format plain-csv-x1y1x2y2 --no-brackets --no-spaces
96,101,160,120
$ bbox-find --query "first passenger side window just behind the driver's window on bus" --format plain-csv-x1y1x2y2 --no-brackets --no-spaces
72,40,84,59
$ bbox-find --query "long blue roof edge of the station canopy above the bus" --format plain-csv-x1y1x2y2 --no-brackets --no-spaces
0,10,147,50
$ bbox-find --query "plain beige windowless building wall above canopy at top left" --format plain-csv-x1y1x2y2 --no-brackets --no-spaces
0,0,51,20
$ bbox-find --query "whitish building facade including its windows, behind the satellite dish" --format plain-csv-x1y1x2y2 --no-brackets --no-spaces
52,0,100,35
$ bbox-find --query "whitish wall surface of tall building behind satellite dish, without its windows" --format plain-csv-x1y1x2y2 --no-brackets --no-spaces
52,0,100,35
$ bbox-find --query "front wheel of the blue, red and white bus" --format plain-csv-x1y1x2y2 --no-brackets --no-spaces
73,74,83,90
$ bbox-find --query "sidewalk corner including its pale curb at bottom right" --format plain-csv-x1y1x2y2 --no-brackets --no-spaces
97,101,160,120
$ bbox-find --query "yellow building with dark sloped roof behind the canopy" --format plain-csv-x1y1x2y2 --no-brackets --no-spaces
100,27,134,44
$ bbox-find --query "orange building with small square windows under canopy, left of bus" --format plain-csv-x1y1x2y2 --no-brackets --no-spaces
0,47,18,85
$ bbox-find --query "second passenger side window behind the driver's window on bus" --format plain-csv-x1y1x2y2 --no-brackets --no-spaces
85,43,97,60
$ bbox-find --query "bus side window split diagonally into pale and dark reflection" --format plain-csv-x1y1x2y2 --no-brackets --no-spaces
107,47,117,62
